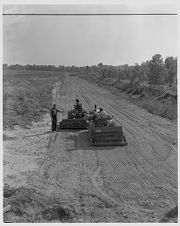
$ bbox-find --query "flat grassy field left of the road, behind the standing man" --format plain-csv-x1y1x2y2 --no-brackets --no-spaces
3,70,63,129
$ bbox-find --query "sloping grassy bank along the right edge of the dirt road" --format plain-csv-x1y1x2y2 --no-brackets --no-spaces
80,74,177,120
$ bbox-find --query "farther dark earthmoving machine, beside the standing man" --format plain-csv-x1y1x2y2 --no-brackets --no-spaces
59,109,88,129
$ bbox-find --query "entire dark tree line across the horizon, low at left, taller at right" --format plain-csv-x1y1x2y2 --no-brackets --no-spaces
3,54,177,86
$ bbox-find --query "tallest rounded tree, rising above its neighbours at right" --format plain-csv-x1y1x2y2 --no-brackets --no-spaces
147,54,164,85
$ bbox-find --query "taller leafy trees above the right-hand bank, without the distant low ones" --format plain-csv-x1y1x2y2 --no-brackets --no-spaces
99,54,177,86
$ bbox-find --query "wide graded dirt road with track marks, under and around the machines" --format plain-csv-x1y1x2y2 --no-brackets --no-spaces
4,76,178,222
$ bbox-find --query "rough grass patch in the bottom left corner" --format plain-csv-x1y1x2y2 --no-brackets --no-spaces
3,185,73,223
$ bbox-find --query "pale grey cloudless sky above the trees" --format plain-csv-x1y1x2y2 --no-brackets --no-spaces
3,5,177,66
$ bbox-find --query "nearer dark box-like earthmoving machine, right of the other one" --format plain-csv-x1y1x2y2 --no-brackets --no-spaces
88,116,127,146
